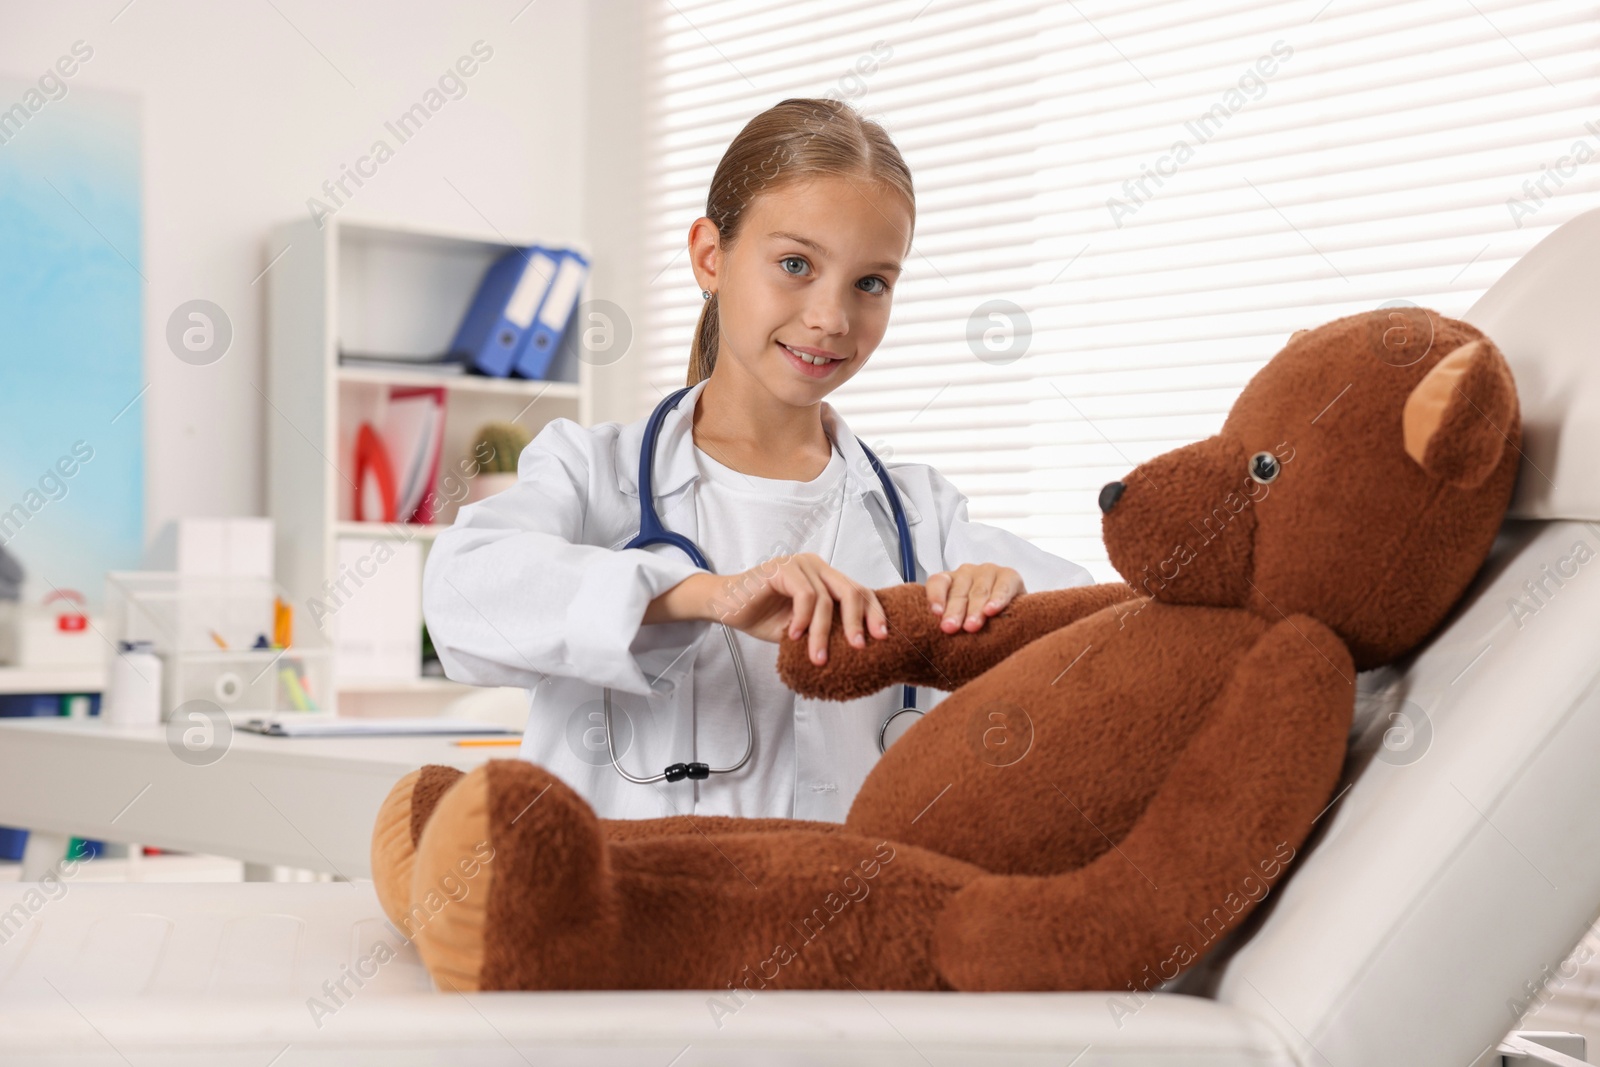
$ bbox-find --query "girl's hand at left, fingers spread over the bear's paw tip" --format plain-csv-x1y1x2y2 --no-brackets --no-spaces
704,552,890,664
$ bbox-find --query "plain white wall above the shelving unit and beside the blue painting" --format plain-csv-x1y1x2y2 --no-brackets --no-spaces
0,0,640,547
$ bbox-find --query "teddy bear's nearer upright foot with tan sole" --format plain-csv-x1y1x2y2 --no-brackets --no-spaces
400,760,624,990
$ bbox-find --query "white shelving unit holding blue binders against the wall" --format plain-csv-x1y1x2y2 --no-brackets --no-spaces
266,216,594,715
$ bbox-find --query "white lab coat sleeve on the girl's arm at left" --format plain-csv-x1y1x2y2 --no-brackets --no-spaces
422,419,710,696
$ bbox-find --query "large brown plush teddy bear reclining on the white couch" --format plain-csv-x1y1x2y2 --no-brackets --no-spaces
373,307,1520,991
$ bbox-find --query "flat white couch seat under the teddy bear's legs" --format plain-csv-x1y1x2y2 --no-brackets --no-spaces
0,883,1294,1067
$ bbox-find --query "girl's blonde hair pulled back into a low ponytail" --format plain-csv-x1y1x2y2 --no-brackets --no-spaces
688,98,917,386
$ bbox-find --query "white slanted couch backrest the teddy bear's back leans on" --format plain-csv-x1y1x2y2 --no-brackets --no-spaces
1203,522,1600,1067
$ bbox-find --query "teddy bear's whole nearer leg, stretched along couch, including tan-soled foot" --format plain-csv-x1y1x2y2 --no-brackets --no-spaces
400,760,982,991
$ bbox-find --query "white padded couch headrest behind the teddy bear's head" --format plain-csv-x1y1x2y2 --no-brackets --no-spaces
1462,210,1600,520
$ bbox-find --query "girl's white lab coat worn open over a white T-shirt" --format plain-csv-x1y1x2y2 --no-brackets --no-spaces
422,382,1093,822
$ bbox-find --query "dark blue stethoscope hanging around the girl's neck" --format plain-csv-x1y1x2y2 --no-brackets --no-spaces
605,386,922,785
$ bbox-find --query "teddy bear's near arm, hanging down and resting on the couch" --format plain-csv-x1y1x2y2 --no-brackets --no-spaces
934,616,1355,990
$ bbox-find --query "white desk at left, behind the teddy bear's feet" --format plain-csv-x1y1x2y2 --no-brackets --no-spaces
0,718,499,878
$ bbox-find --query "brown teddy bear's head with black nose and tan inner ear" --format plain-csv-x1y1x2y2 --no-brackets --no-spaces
1099,306,1522,670
